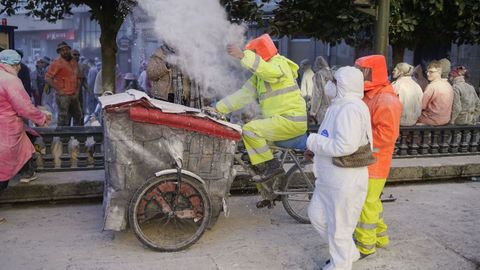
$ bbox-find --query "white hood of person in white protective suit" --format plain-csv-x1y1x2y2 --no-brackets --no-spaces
334,66,363,102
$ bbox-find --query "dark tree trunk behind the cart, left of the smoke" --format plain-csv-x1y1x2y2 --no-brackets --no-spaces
97,1,124,93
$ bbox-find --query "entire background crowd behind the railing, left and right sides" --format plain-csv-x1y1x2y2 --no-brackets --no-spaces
18,39,480,130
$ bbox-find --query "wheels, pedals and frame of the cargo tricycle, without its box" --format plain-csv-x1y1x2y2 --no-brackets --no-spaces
128,134,315,252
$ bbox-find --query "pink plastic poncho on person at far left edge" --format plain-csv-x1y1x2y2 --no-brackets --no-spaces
0,63,47,181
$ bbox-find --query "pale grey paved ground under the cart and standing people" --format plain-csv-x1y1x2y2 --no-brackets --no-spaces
0,182,480,270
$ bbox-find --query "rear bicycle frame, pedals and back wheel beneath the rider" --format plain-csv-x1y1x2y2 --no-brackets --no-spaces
235,135,315,224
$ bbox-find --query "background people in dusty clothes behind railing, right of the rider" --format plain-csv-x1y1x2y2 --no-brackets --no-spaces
301,56,480,126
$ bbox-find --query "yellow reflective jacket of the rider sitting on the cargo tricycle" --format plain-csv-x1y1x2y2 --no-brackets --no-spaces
216,50,307,122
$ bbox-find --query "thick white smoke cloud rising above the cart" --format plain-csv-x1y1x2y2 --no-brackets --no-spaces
138,0,246,97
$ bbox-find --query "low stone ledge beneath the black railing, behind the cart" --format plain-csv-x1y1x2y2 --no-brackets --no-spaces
0,155,480,203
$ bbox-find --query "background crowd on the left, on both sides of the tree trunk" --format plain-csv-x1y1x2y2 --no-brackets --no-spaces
18,42,195,126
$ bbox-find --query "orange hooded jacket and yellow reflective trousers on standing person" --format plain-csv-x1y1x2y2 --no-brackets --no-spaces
355,55,402,256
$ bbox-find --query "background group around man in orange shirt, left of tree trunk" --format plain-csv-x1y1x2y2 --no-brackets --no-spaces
19,42,121,126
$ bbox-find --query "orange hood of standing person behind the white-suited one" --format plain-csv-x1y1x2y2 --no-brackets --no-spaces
355,55,389,91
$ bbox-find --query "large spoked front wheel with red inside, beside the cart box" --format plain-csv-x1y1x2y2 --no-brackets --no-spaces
129,174,211,251
